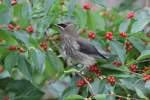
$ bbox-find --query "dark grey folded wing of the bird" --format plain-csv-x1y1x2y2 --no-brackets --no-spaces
77,38,107,59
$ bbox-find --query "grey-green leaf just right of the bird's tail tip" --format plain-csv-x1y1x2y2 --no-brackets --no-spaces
110,41,126,64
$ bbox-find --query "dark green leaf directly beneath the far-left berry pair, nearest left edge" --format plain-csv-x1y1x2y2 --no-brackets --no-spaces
4,52,18,71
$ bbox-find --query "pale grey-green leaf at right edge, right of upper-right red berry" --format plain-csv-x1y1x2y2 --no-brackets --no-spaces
131,19,150,33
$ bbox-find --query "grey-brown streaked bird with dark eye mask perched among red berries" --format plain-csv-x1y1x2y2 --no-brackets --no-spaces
55,22,116,68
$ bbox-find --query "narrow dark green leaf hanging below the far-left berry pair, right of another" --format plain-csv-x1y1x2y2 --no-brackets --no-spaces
18,55,32,80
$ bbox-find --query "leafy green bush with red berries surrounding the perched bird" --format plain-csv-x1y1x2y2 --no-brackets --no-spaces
0,0,150,100
